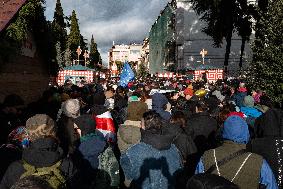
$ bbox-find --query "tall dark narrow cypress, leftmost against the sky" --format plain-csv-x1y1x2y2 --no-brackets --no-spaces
52,0,67,50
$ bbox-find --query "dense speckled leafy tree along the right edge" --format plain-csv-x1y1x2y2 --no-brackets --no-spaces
247,0,283,102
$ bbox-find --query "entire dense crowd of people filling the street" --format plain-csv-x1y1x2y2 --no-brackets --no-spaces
0,77,283,189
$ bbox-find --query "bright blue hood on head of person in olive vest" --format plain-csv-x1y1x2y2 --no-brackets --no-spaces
222,116,250,144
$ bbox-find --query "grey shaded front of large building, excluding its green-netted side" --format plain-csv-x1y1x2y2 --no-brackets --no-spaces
175,0,251,73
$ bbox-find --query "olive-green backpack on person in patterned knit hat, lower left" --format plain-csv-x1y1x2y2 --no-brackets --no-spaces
20,161,66,189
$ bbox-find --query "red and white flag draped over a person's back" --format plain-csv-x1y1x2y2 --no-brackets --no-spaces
94,111,116,142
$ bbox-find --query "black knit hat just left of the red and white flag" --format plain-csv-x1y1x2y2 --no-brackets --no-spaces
74,114,95,136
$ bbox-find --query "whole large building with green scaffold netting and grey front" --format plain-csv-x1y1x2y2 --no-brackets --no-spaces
149,0,254,73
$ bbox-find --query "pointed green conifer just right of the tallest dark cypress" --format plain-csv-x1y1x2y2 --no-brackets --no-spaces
67,10,81,59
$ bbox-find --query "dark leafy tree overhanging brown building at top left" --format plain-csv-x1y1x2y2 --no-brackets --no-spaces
0,0,58,75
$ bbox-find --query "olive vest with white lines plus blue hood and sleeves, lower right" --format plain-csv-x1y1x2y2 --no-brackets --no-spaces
196,116,278,189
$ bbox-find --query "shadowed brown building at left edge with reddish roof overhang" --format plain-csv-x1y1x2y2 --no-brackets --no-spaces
0,0,50,104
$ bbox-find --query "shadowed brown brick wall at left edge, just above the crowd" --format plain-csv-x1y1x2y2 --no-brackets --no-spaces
0,52,49,103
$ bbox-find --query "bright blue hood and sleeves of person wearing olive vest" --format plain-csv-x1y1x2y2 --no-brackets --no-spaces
195,116,278,189
